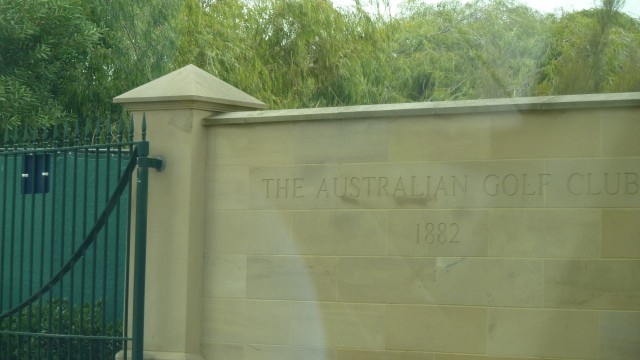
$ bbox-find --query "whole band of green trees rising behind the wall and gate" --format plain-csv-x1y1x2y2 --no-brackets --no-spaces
0,0,640,127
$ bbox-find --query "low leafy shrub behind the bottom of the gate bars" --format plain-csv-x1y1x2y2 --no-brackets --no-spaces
0,300,123,360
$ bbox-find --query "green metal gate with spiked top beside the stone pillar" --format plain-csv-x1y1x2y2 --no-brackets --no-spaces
0,116,161,360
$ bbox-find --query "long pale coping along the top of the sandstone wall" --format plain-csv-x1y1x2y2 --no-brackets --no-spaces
202,92,640,126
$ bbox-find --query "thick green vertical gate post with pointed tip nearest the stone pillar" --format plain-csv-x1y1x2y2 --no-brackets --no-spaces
133,114,149,360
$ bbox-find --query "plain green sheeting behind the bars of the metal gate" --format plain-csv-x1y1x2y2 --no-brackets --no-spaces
0,153,129,316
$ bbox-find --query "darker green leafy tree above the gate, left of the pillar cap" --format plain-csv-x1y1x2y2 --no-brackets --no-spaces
0,0,180,128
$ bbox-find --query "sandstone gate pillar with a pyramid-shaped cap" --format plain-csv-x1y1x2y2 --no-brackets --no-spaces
114,65,266,360
